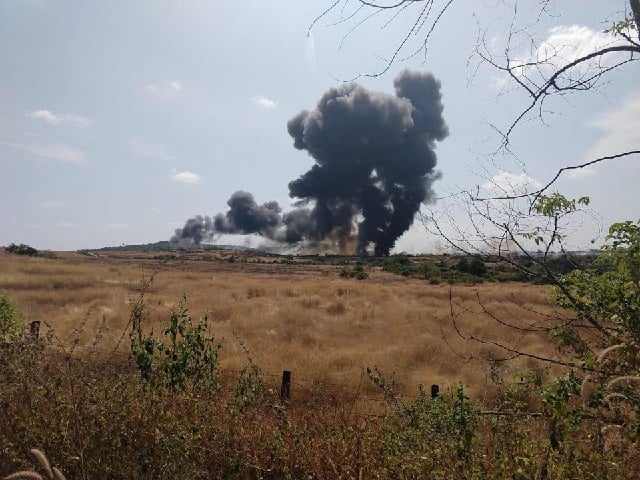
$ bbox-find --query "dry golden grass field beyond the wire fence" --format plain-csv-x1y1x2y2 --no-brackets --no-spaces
0,246,568,399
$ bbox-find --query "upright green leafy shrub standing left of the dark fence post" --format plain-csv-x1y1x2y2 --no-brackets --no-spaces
130,295,222,390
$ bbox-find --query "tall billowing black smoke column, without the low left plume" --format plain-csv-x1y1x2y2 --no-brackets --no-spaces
287,70,448,255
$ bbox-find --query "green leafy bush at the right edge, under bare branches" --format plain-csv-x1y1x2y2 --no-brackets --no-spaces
553,221,640,437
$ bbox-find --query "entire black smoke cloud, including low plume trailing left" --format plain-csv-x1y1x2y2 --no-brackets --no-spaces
171,70,448,255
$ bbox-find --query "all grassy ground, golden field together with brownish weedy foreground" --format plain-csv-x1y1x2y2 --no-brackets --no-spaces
0,251,640,480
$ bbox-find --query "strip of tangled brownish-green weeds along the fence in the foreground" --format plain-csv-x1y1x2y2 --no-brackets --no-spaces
0,344,640,480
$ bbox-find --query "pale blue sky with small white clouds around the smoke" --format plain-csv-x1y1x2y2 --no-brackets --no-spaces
0,0,640,253
